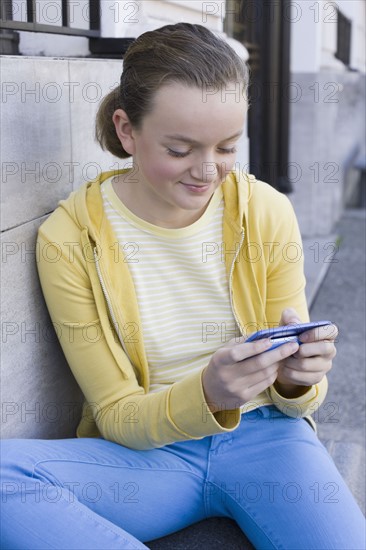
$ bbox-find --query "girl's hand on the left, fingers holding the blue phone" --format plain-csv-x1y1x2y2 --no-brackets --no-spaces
202,337,299,413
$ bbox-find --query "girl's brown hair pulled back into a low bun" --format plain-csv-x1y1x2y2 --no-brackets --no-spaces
95,23,249,158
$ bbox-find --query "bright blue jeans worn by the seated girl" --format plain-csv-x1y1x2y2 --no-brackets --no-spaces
1,407,366,550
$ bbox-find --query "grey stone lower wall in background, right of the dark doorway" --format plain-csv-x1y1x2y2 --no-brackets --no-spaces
289,71,366,237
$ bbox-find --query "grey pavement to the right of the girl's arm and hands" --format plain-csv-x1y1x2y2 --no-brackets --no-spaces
311,209,366,446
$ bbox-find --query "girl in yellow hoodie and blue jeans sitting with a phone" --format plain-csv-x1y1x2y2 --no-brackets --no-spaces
2,23,365,549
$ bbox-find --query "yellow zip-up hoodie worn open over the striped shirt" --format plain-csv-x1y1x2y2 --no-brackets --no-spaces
38,171,327,449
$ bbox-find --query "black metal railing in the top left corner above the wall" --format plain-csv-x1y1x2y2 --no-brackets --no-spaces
0,0,100,38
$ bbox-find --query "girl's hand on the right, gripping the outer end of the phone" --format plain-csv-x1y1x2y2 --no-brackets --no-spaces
274,308,338,398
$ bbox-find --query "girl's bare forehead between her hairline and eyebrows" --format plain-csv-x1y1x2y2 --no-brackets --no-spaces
143,83,247,142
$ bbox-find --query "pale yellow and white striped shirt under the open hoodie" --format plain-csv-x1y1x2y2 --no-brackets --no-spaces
102,178,240,391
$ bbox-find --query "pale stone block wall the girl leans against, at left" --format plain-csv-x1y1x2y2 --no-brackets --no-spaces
1,56,126,438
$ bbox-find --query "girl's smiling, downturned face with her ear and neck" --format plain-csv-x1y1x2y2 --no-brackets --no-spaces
114,83,247,228
